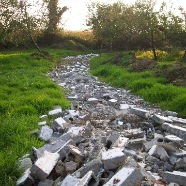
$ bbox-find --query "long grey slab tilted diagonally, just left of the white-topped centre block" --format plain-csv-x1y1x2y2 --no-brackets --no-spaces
72,159,102,178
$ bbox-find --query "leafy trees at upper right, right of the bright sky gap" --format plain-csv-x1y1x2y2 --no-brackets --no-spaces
88,0,186,60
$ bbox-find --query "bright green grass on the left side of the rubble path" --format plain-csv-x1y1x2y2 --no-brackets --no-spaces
0,49,86,186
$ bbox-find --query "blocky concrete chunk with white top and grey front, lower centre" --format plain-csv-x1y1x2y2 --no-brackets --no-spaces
101,148,126,170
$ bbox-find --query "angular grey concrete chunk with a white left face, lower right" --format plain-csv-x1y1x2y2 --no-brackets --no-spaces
148,145,169,161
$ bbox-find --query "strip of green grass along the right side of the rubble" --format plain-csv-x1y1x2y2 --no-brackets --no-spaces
90,52,186,117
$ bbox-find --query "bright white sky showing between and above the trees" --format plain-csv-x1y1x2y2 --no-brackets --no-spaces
59,0,186,30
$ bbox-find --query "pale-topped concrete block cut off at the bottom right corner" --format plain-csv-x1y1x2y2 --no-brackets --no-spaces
160,171,186,185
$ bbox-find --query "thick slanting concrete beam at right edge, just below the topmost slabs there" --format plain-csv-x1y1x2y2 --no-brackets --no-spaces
162,123,186,141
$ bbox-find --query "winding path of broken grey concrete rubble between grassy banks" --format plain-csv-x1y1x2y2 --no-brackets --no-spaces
17,54,186,186
